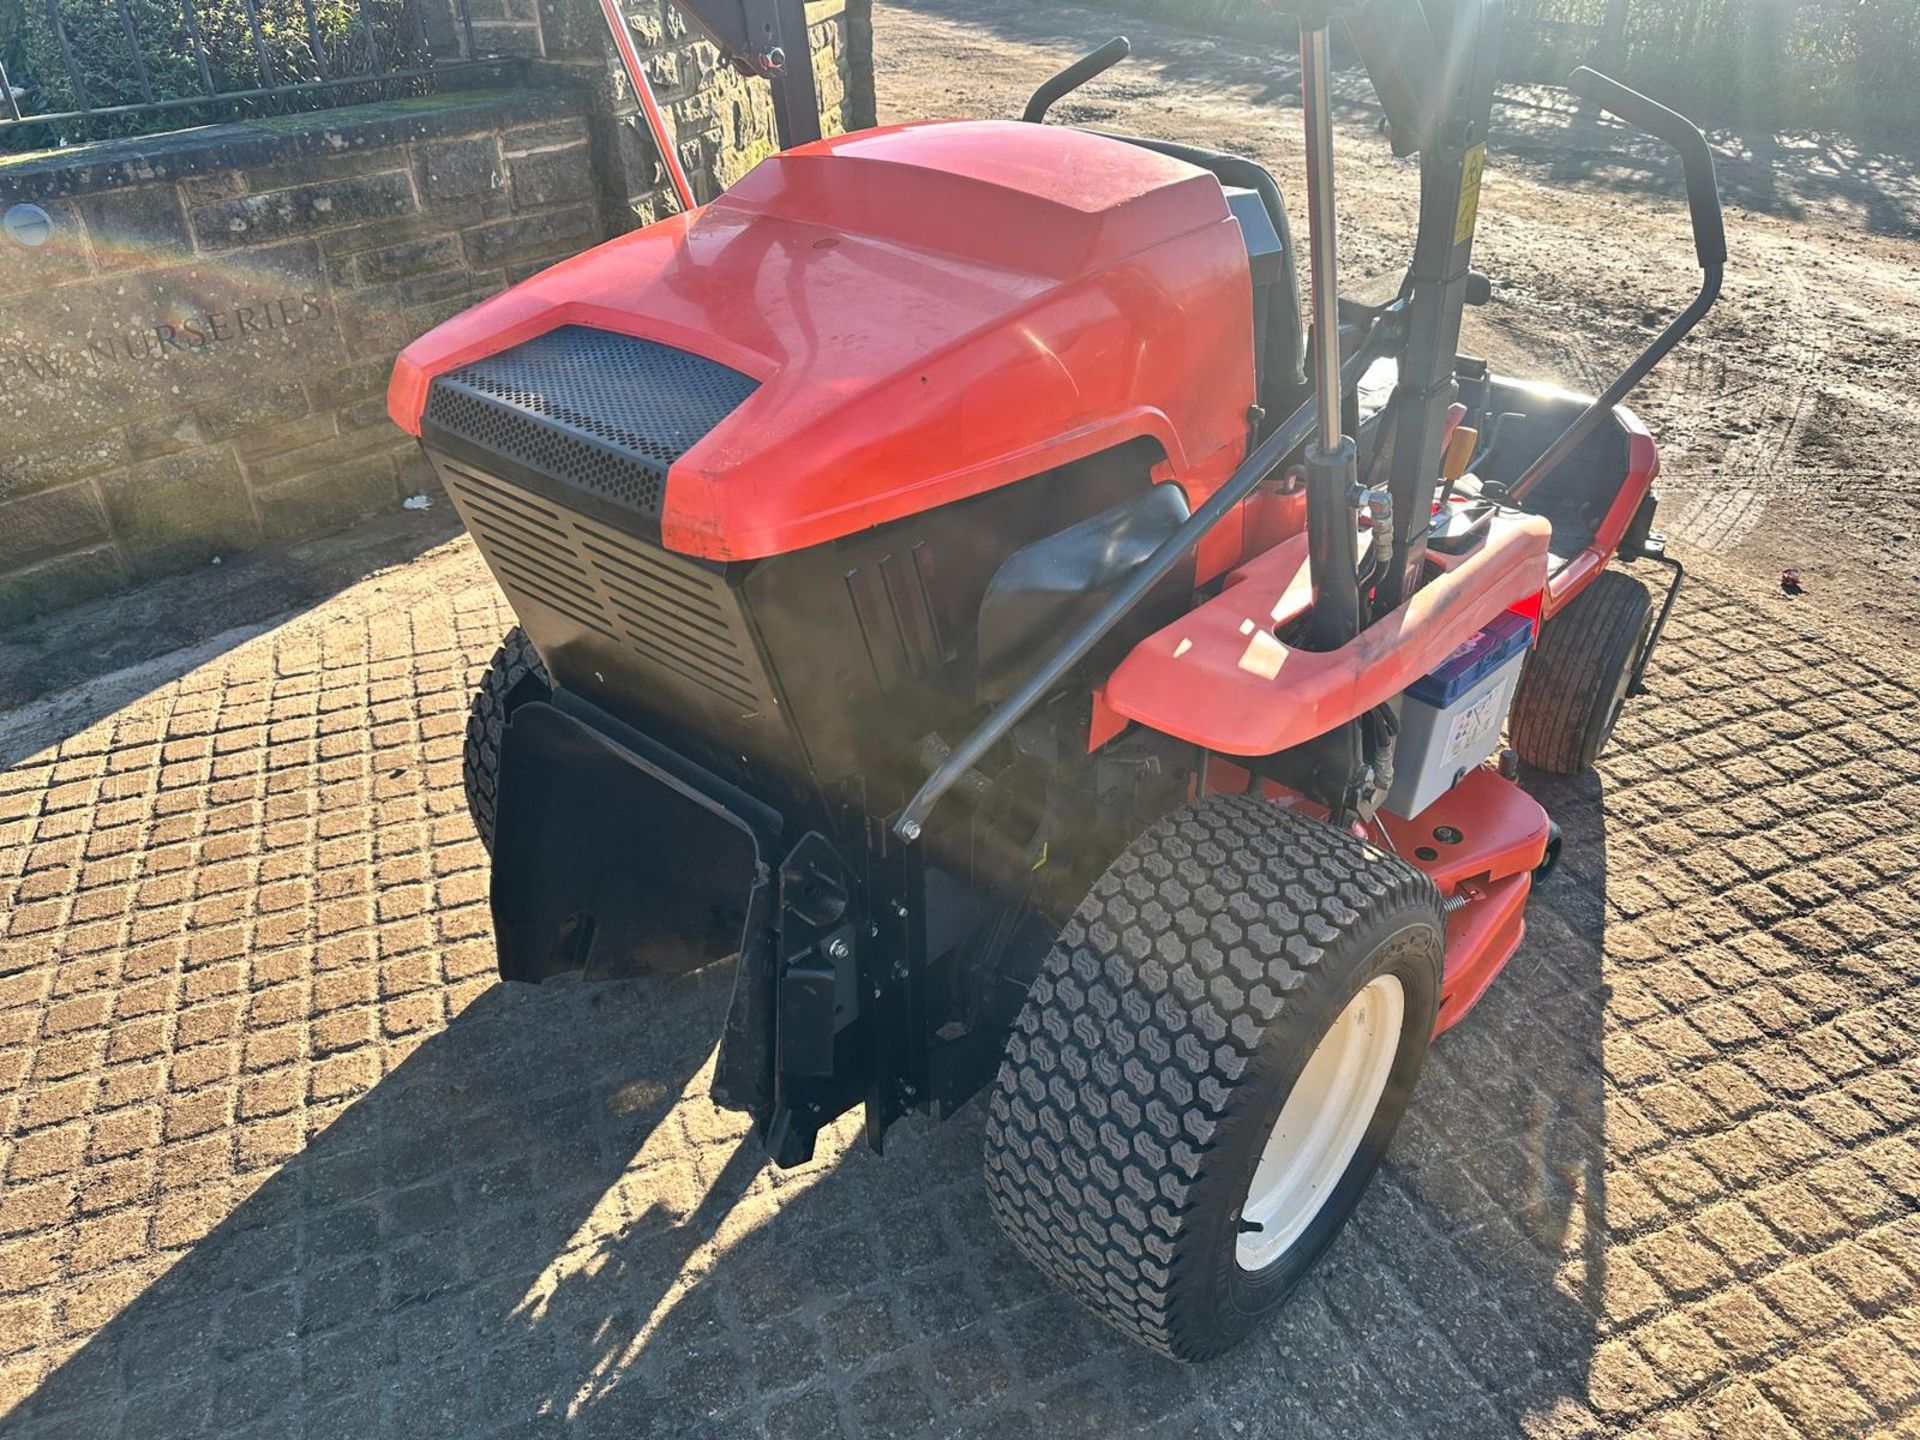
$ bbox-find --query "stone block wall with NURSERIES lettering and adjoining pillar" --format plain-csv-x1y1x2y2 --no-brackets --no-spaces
0,0,870,628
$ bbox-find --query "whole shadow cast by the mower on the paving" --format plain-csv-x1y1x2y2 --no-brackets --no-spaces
6,781,1605,1436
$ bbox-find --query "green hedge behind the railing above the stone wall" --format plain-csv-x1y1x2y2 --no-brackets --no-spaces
0,0,424,150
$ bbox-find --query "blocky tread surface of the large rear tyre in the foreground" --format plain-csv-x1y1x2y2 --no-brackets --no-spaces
985,795,1440,1359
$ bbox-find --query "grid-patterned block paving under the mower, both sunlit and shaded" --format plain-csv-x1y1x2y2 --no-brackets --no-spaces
0,547,1920,1438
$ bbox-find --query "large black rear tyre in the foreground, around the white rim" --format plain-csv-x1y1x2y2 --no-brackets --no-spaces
985,795,1444,1359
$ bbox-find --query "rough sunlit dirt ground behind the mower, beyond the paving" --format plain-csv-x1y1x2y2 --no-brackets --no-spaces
874,0,1920,647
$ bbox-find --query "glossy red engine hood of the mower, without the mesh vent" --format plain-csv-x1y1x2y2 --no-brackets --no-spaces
388,121,1254,561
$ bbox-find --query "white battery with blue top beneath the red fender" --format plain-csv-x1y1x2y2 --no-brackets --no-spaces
1386,611,1534,818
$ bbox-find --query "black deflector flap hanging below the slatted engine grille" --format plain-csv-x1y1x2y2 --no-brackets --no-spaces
492,689,875,1165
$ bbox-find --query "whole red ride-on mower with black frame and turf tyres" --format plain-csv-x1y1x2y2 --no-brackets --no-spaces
390,0,1726,1359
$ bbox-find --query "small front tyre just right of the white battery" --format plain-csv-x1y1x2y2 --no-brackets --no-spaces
1507,570,1653,776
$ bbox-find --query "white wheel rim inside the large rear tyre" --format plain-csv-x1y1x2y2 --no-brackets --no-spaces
1235,975,1407,1269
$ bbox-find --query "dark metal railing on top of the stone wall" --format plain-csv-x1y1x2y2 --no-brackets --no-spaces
0,0,497,150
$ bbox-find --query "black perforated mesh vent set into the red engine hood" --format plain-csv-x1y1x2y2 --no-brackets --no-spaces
426,324,758,518
